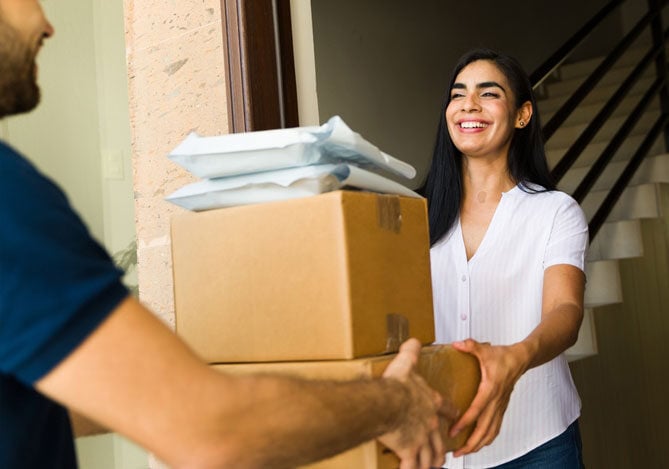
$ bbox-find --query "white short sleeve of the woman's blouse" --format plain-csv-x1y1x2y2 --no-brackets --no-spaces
544,195,588,272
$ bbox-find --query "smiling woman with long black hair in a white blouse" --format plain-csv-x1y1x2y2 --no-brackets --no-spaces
425,49,588,469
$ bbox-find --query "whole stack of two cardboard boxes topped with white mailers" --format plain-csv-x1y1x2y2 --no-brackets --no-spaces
168,118,480,469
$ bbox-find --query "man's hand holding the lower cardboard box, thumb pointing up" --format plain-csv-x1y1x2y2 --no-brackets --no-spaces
379,339,454,469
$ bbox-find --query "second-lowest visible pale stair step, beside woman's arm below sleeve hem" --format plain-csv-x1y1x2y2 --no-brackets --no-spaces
585,259,623,308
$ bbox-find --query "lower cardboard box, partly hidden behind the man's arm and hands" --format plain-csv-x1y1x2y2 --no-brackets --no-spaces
214,345,481,469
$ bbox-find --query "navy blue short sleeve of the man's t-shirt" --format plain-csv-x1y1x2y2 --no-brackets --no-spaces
0,148,128,384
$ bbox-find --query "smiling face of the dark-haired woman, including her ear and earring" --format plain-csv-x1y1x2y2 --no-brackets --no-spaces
446,60,531,162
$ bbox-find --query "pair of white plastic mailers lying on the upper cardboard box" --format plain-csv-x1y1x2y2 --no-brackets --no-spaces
167,116,420,211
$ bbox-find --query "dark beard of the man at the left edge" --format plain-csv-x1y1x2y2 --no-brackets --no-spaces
0,18,40,117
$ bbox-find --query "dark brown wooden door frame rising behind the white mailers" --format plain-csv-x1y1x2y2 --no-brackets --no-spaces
221,0,299,132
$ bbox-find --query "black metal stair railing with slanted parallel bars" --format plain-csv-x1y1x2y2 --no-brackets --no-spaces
530,0,669,238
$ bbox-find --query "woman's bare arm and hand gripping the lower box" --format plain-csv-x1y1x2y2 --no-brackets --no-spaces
450,264,585,456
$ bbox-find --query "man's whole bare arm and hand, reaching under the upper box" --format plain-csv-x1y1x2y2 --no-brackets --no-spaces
37,298,443,469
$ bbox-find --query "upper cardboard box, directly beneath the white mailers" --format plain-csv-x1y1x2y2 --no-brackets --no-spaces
172,191,434,363
